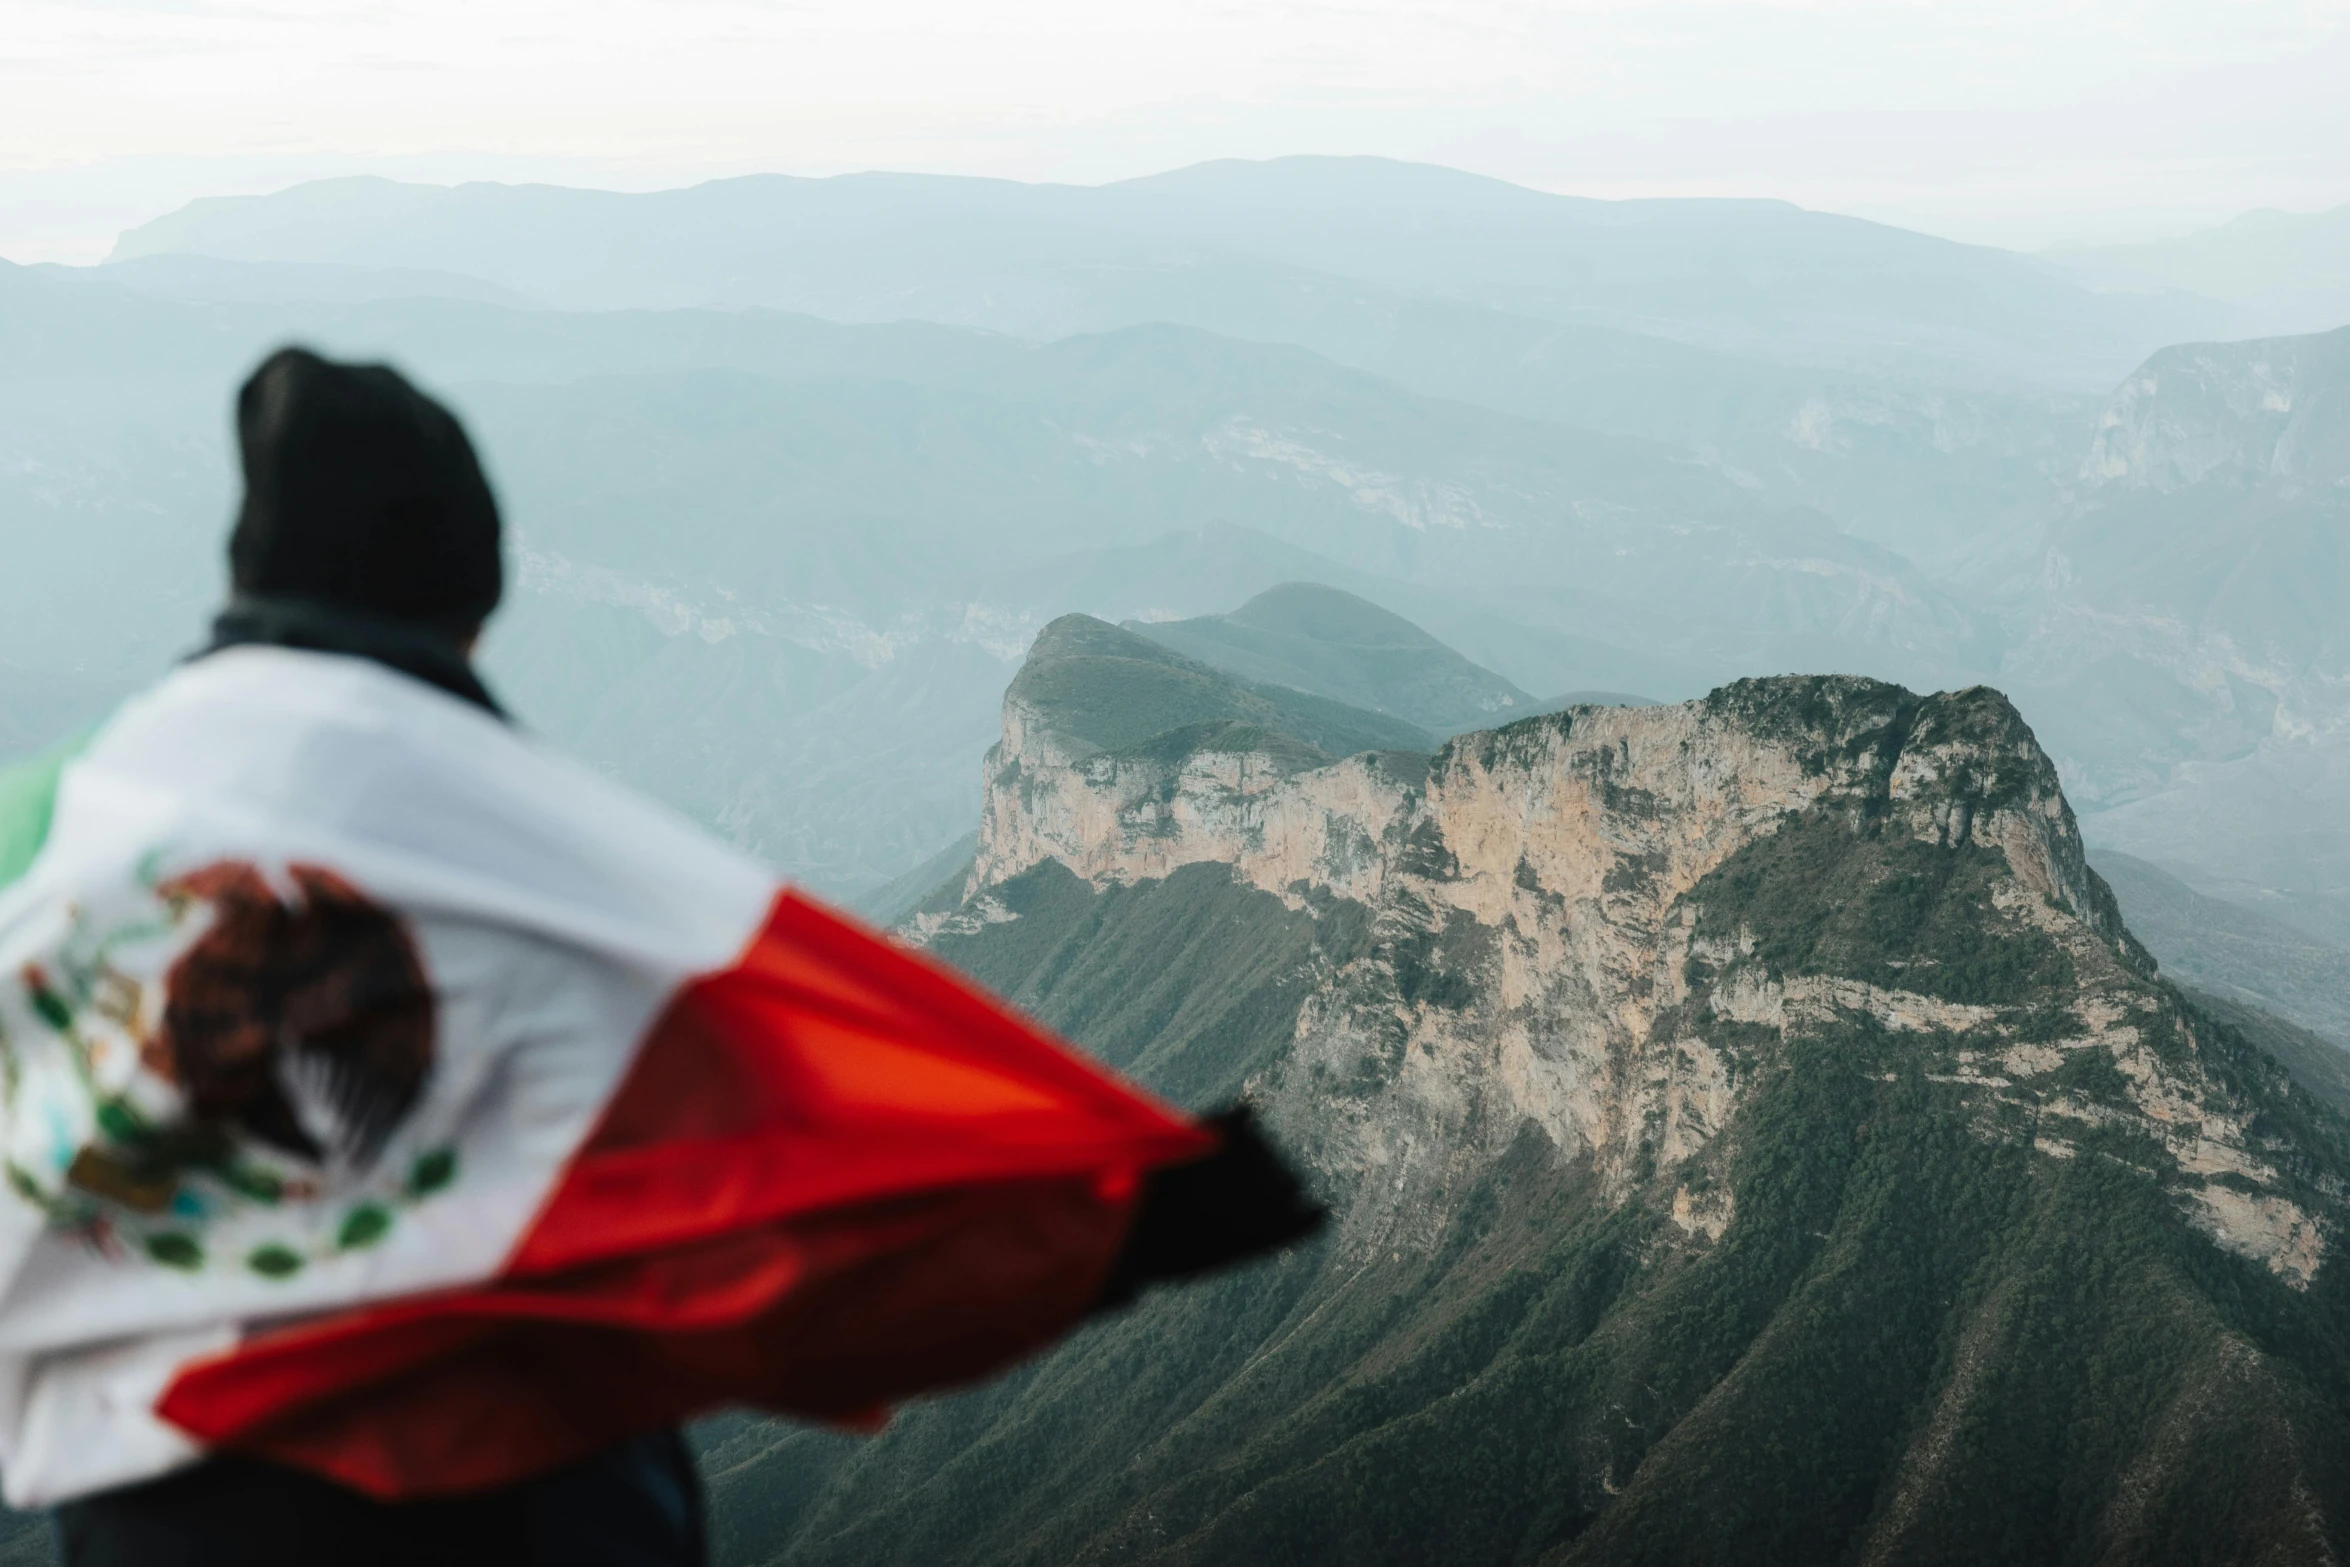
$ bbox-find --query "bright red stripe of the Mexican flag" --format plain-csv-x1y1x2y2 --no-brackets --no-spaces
157,893,1210,1497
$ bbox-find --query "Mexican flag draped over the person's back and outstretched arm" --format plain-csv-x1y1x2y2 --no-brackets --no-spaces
0,648,1210,1506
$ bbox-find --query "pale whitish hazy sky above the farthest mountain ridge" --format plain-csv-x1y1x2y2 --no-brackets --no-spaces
0,0,2350,261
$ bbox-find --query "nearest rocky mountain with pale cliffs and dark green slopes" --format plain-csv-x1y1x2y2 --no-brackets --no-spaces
705,594,2350,1567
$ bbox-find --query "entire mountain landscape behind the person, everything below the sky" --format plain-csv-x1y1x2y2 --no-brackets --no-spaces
0,146,2350,1562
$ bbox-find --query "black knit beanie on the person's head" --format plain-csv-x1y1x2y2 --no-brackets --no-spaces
228,348,505,637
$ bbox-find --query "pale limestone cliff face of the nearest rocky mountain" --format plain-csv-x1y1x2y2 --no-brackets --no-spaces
954,648,2327,1285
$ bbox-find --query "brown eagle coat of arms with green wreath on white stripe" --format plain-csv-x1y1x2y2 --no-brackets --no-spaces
0,860,456,1278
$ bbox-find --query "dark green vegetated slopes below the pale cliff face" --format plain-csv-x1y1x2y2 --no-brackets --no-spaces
714,820,2350,1565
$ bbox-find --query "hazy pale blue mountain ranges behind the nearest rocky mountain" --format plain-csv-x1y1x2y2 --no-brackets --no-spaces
0,160,2350,967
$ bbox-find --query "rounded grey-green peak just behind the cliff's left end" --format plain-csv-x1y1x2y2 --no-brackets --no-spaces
1126,583,1539,738
